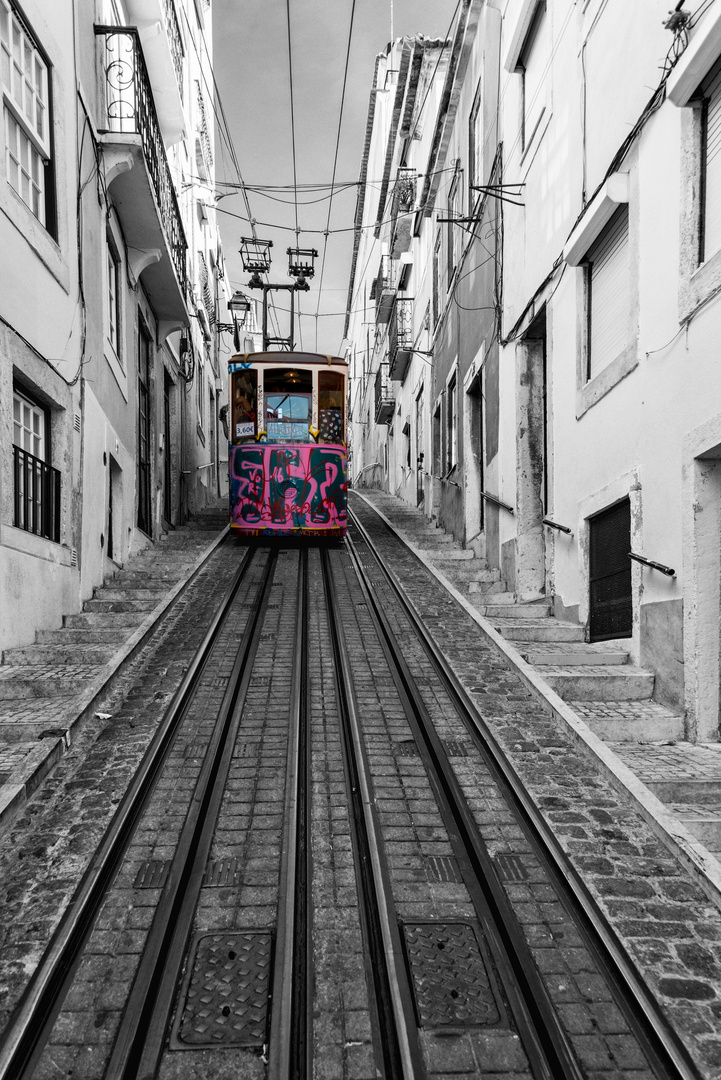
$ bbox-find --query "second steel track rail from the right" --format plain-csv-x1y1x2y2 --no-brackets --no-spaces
346,527,584,1080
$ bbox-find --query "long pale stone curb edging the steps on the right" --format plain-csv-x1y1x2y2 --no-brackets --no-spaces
354,490,721,908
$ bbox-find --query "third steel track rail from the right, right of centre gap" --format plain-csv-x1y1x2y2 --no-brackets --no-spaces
321,549,425,1080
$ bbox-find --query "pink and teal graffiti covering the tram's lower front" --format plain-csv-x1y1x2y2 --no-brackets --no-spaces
230,443,346,532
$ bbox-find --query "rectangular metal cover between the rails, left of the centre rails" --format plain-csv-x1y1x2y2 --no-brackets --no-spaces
171,930,273,1050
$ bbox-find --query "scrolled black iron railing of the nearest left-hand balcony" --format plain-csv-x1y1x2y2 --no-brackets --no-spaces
95,26,188,293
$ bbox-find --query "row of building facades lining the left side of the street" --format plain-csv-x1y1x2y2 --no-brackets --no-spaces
0,0,225,647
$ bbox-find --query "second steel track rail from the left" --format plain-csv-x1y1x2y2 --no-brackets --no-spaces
105,552,277,1080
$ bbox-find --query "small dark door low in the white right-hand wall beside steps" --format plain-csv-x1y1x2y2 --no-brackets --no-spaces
588,499,632,642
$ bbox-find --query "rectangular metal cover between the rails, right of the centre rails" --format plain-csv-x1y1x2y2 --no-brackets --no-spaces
403,922,507,1027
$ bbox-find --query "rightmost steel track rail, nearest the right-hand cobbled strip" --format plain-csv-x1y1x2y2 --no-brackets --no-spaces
349,510,703,1080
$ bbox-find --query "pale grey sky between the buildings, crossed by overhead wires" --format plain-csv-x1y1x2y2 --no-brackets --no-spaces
213,0,457,353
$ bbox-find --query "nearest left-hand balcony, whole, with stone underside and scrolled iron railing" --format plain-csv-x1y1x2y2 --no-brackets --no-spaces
95,26,188,329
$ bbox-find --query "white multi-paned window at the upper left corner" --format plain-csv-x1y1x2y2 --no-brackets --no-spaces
0,0,52,229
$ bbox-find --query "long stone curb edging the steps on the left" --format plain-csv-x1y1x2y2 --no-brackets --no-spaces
0,526,229,836
